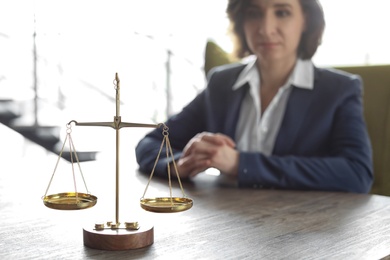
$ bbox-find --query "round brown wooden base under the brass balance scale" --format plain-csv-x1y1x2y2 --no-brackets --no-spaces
83,224,154,251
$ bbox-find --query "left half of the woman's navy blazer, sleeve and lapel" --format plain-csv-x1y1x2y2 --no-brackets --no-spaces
135,64,244,176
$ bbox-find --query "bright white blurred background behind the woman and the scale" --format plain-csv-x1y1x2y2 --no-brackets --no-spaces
0,0,390,159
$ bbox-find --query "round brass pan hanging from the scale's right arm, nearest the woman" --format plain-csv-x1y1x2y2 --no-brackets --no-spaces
141,197,192,213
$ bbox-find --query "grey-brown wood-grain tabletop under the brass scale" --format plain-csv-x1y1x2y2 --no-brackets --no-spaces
0,124,390,259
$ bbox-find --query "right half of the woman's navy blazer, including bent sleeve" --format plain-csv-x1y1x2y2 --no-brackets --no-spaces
238,71,373,193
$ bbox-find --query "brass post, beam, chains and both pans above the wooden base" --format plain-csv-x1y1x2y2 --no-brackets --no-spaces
42,74,193,213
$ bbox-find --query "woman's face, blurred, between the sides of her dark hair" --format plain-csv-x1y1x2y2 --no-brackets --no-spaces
244,0,305,62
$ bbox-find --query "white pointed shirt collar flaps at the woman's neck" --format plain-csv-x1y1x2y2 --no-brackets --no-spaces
232,59,314,90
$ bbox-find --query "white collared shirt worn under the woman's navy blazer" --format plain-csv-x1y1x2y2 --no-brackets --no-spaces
233,59,314,155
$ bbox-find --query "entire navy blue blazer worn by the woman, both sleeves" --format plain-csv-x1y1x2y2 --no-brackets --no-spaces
136,64,373,193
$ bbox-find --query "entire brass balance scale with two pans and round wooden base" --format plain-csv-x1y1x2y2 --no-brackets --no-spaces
42,73,193,250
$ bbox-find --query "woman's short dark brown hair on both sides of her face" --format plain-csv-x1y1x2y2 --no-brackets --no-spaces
226,0,325,60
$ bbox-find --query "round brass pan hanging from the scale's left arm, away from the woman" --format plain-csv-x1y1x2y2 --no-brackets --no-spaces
43,192,97,210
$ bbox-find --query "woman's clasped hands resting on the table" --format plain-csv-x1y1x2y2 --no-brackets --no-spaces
177,132,239,177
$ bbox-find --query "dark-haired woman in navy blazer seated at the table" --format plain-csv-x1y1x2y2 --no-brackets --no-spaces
136,0,373,193
